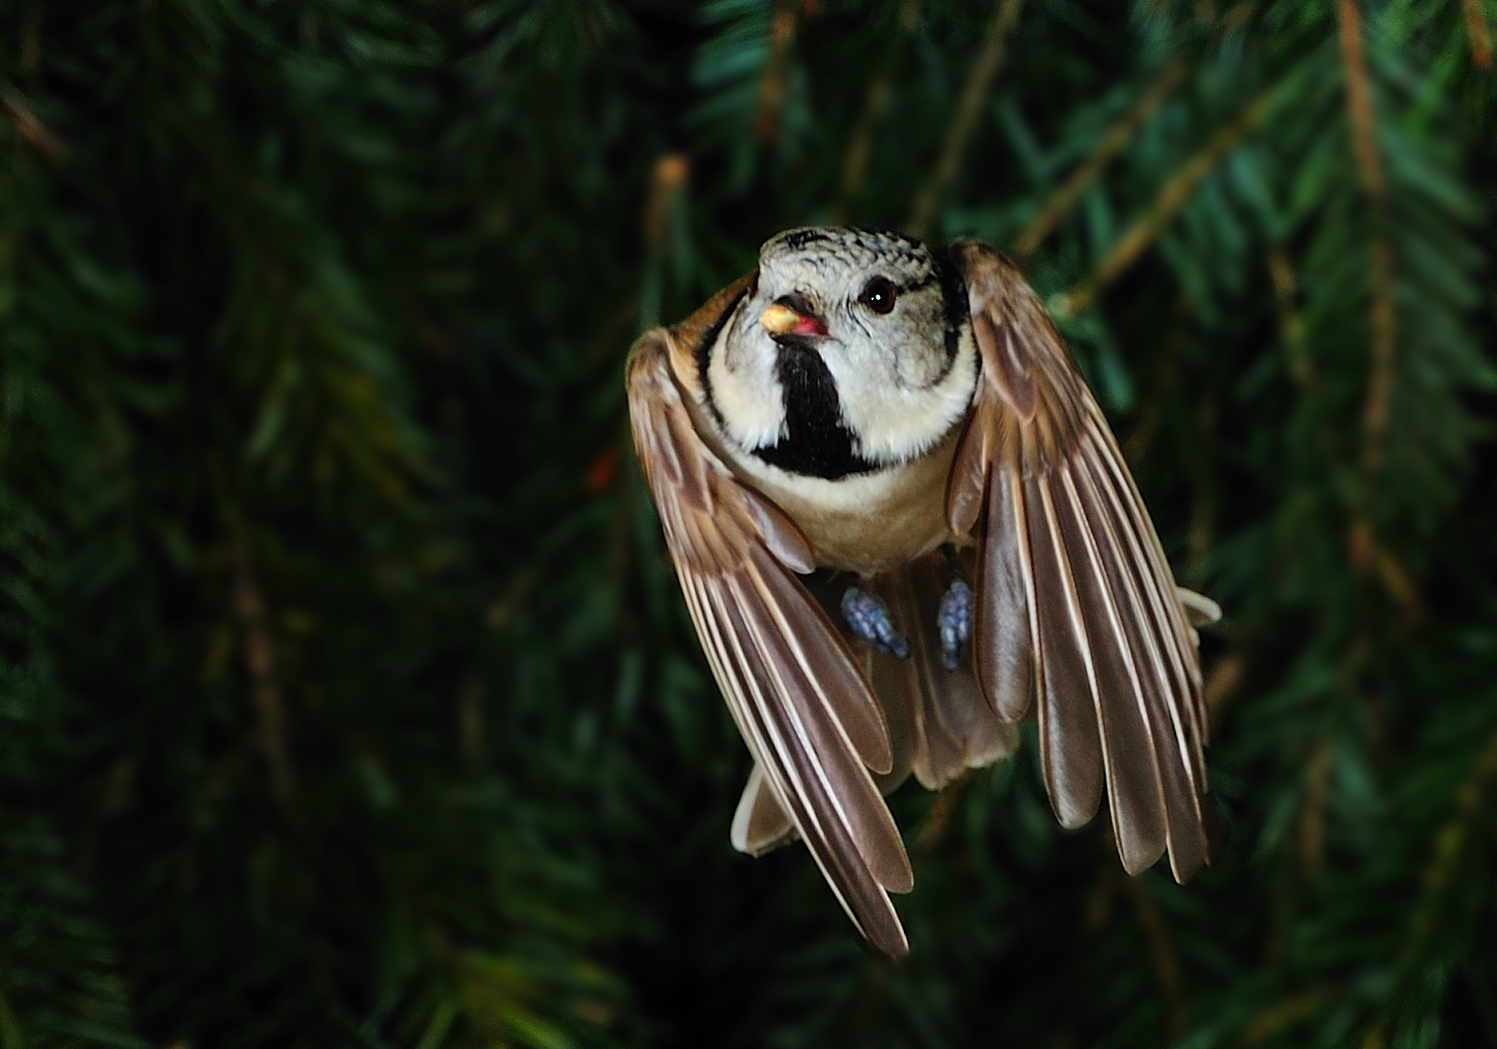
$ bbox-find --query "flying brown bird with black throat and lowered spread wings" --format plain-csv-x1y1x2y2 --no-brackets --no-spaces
624,227,1220,959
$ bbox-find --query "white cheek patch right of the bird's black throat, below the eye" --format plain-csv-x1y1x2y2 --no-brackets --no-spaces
826,324,978,462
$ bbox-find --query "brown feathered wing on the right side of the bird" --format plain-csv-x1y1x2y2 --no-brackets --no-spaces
946,244,1208,881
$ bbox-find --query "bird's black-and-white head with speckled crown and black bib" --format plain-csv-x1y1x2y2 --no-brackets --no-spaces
705,227,976,479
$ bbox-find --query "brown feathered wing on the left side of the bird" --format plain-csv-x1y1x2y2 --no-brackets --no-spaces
627,296,913,956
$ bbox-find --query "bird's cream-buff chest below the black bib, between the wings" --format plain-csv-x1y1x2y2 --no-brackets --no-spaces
732,432,957,576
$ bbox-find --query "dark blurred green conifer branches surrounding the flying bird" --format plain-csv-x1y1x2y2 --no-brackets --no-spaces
0,0,1497,1049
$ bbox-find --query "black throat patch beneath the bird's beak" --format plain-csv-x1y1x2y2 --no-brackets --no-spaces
754,337,879,480
